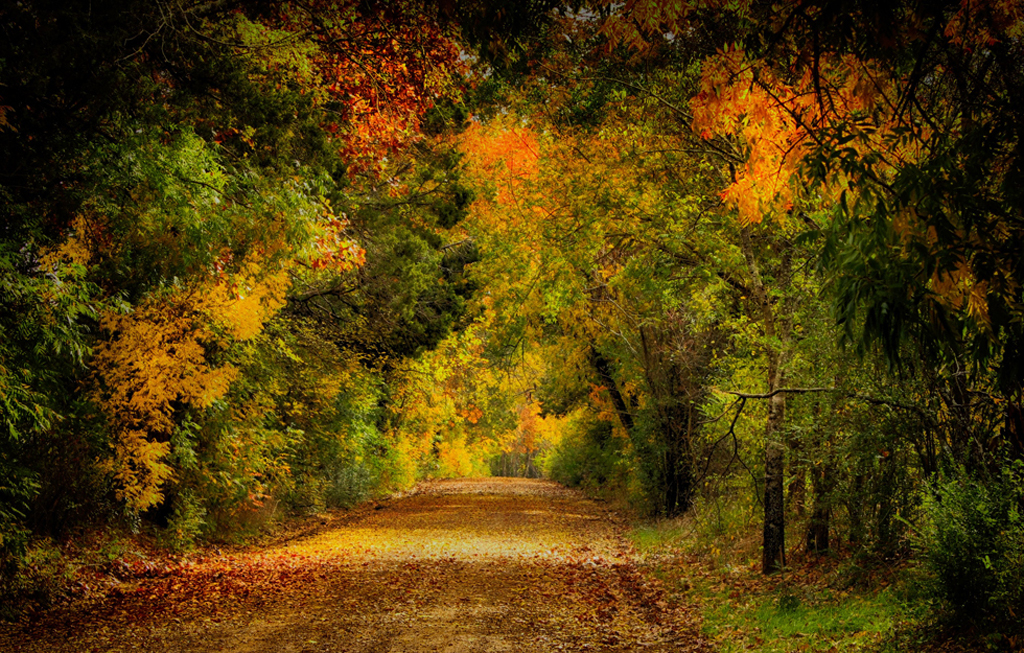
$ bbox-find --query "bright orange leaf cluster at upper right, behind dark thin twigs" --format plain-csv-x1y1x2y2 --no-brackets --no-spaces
690,43,919,223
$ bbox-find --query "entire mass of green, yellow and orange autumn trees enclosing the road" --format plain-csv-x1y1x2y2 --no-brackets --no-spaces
0,0,1024,646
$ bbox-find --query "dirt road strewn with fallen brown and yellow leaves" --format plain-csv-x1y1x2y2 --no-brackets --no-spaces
0,479,710,653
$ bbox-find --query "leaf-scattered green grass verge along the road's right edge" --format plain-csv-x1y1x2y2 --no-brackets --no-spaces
631,516,923,653
